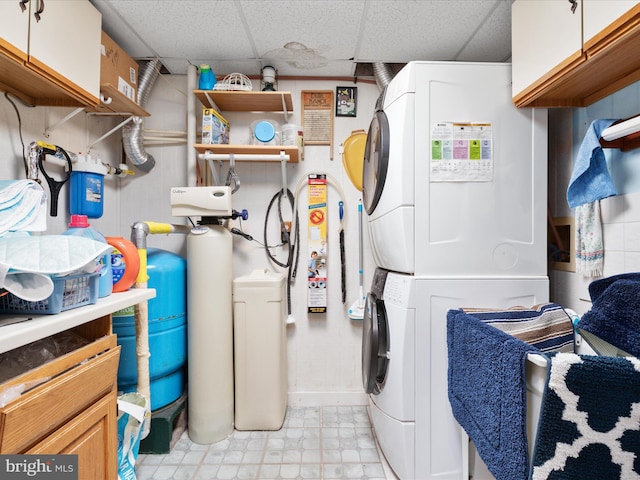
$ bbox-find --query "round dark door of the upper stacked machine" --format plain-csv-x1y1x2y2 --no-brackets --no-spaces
362,110,389,215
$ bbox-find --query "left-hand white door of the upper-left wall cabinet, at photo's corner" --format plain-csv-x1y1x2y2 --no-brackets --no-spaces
0,1,31,61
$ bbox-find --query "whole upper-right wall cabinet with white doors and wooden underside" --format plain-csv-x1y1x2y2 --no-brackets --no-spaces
512,0,640,107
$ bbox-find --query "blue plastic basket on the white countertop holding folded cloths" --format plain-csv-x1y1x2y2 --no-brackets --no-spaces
0,273,100,314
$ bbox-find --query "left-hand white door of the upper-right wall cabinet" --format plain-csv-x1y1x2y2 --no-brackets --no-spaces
511,0,582,97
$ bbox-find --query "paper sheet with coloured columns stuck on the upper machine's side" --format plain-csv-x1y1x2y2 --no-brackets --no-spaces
430,122,493,182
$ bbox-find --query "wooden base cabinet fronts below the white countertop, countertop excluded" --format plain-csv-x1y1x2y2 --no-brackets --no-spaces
0,317,120,480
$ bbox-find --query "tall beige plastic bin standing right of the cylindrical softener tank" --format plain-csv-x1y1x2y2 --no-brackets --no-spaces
233,270,287,430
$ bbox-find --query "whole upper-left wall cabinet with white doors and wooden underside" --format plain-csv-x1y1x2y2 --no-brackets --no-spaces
0,0,102,106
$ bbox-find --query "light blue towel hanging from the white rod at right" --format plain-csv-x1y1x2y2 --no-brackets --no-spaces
567,118,618,208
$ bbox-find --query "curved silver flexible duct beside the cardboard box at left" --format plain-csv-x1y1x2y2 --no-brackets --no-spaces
122,58,160,172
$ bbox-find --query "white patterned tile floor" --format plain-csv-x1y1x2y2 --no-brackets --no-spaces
136,406,395,480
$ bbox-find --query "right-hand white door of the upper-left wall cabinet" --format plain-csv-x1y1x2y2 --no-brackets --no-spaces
28,0,102,104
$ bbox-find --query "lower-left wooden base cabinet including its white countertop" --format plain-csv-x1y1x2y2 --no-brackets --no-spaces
0,289,155,480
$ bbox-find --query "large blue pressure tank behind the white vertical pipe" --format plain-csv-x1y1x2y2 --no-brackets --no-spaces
113,248,187,411
